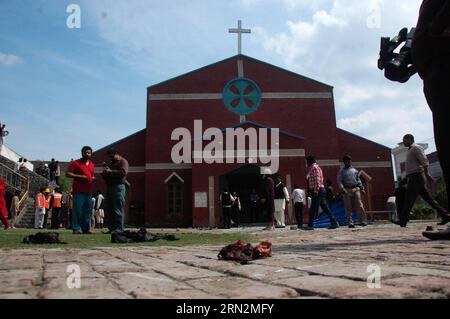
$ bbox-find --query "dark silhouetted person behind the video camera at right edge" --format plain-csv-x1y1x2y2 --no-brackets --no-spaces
412,0,450,212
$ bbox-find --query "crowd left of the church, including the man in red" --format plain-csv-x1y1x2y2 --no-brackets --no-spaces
0,146,130,234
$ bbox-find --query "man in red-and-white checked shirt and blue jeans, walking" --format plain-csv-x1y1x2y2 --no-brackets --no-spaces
306,156,339,230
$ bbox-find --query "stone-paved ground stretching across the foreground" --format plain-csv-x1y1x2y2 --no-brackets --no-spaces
0,224,450,299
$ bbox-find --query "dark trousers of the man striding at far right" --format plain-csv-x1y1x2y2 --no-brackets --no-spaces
400,173,446,225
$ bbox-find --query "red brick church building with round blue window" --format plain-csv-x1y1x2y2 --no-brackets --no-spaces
94,54,394,227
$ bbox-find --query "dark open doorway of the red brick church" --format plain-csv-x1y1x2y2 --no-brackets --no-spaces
219,165,267,225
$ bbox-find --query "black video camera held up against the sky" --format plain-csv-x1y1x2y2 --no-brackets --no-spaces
378,28,417,83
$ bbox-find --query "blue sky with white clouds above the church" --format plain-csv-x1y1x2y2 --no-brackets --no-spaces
0,0,434,160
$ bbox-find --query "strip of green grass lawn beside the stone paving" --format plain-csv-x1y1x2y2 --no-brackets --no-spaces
0,229,257,249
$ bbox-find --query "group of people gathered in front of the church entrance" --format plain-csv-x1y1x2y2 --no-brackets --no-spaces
219,155,367,230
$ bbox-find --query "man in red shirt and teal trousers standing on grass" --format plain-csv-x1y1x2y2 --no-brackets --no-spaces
66,146,95,234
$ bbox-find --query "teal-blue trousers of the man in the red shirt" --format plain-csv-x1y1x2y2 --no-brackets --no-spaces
72,193,92,233
